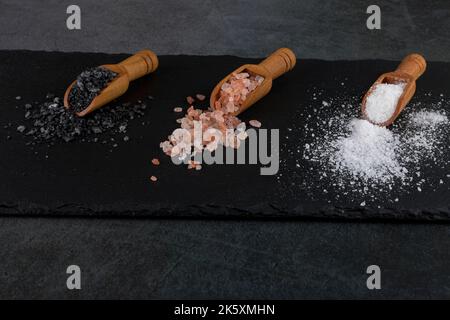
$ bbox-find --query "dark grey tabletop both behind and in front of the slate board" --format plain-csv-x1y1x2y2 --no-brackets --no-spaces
0,0,450,298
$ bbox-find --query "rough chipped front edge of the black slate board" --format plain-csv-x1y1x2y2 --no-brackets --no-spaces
0,203,450,222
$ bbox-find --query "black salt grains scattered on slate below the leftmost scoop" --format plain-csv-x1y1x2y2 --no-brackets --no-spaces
17,94,153,146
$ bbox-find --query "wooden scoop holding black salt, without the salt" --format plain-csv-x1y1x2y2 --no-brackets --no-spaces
64,50,158,117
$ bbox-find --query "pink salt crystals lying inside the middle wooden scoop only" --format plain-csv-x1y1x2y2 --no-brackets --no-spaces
214,72,264,113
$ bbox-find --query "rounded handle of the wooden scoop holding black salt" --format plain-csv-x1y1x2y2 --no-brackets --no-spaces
119,50,158,81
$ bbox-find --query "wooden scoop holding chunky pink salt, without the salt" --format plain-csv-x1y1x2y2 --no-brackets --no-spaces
209,48,296,115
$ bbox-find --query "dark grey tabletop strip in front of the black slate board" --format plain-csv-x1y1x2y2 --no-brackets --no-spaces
0,218,450,299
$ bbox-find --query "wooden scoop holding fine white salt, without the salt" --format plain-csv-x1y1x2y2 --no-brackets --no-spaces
361,53,427,127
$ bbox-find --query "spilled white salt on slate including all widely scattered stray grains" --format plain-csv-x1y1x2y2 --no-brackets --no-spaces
284,88,450,205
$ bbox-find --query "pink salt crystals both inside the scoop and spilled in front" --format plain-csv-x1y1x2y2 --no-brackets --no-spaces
160,72,264,170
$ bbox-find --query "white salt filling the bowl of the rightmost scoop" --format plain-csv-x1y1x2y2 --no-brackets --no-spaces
366,83,405,123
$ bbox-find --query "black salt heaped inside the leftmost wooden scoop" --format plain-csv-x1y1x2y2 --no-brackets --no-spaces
68,67,117,112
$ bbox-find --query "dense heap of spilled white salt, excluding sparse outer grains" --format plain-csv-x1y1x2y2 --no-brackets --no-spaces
322,110,449,184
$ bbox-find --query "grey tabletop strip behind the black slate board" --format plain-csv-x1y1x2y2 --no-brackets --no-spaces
0,0,450,61
